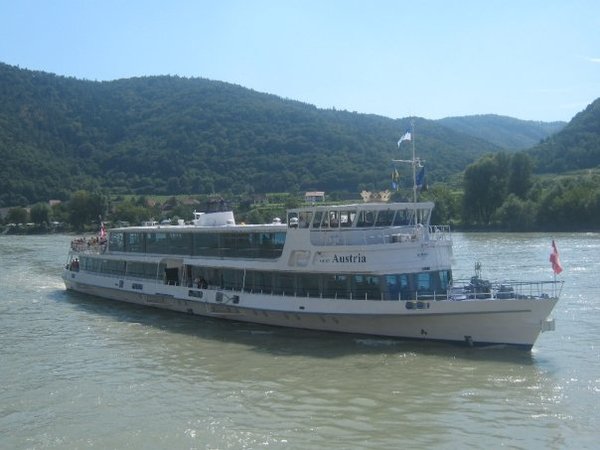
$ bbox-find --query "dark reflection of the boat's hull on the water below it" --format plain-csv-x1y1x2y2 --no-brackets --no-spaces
58,291,534,364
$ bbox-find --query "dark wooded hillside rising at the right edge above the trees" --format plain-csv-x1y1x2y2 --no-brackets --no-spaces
529,98,600,173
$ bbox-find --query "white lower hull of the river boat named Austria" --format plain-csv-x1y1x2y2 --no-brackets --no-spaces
63,271,557,349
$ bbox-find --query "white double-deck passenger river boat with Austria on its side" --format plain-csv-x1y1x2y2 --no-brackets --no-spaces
63,139,562,349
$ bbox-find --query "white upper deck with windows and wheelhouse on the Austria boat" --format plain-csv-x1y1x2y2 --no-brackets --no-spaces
71,202,451,264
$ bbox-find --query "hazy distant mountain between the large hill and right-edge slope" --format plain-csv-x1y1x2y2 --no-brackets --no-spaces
437,114,566,150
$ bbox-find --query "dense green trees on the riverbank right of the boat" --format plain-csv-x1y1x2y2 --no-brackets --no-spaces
421,152,600,231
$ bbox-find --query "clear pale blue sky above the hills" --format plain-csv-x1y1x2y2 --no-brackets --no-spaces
0,0,600,121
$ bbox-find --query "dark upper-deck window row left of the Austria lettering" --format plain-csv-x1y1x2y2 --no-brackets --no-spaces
108,231,285,259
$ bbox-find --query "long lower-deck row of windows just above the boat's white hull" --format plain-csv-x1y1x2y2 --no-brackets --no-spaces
81,257,451,300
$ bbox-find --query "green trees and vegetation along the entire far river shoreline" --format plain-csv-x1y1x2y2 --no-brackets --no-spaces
0,165,600,234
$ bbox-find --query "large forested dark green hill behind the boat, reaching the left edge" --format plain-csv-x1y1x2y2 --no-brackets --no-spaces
0,64,516,206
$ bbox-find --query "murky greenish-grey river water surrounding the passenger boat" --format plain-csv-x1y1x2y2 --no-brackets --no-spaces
0,233,600,449
